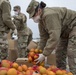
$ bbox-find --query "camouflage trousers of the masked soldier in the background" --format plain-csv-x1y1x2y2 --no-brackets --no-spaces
18,35,28,58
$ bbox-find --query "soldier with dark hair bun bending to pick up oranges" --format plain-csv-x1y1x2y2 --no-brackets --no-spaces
26,0,76,75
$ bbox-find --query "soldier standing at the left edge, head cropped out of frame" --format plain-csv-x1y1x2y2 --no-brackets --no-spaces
0,0,17,61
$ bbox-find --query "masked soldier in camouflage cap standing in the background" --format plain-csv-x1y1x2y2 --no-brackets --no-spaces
13,5,32,57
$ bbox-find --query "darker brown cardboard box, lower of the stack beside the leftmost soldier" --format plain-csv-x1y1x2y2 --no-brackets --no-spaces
8,50,18,62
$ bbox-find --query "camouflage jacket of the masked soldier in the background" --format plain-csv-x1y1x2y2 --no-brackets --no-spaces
13,13,27,31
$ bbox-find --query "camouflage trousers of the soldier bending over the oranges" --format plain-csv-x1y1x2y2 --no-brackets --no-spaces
56,26,76,75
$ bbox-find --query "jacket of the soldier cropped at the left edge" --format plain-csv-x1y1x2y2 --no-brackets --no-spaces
0,0,15,32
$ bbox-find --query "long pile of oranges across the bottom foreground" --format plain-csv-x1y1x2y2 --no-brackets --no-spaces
0,60,73,75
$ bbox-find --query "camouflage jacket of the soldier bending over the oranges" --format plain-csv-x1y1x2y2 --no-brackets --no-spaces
38,7,76,56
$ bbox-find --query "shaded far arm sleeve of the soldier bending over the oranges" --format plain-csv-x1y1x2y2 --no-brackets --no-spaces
37,22,49,50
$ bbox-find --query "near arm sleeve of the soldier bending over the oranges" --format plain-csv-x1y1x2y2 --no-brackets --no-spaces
43,14,61,56
